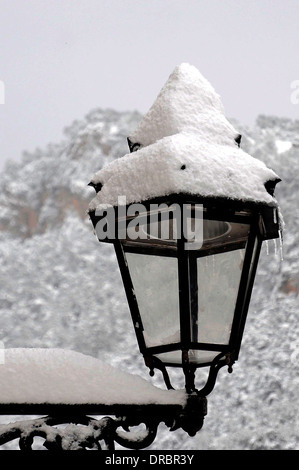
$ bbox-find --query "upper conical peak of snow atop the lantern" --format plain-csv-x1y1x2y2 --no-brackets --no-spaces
129,63,239,147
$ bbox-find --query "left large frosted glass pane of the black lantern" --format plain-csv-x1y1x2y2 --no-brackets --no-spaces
126,253,180,347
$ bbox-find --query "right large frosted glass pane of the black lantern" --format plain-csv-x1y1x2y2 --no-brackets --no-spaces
197,249,245,344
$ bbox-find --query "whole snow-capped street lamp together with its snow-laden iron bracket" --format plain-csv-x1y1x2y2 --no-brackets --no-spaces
0,64,283,450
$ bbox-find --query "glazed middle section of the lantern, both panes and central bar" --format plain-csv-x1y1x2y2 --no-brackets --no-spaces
121,207,252,366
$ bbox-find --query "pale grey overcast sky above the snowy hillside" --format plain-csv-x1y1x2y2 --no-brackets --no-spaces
0,0,299,173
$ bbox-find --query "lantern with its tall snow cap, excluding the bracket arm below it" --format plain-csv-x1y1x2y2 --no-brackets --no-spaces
89,64,282,436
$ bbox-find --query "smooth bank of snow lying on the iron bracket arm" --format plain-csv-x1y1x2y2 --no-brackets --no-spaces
0,348,186,405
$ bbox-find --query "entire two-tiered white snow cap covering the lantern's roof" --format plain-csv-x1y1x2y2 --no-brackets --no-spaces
89,63,280,218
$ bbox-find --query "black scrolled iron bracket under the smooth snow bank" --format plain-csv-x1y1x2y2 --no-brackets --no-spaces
0,395,207,451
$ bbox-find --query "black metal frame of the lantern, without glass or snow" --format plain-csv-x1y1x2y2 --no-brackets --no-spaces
89,193,280,397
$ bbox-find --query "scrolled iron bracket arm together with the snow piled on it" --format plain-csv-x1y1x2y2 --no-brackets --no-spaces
0,348,206,450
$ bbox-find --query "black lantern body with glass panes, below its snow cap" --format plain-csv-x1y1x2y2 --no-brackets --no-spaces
90,180,280,396
